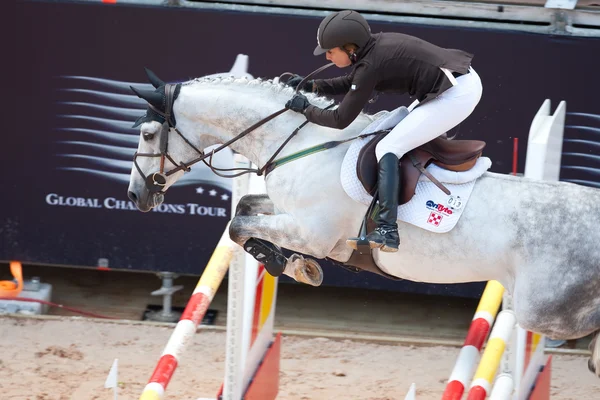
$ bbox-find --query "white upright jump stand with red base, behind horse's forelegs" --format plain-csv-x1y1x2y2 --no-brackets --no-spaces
216,154,281,400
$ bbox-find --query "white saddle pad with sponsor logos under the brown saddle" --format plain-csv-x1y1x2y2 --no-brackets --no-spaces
340,137,492,233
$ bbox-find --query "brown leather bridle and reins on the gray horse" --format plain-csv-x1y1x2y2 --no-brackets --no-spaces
133,63,334,193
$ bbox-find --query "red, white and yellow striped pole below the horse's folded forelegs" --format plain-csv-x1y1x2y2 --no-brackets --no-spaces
139,228,235,400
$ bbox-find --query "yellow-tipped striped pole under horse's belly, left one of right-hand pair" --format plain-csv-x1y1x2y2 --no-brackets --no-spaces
442,281,504,400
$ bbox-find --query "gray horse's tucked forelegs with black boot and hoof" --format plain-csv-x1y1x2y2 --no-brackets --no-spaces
229,214,330,286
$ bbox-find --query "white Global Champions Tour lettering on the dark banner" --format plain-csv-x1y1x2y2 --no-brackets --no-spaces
46,193,227,218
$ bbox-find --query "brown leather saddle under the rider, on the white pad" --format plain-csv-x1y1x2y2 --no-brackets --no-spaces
356,131,485,205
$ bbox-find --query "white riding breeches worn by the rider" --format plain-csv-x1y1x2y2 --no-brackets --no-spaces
375,68,483,161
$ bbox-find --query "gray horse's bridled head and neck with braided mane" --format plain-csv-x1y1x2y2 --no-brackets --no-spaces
128,66,371,211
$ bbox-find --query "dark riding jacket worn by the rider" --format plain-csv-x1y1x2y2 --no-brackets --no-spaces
304,32,473,129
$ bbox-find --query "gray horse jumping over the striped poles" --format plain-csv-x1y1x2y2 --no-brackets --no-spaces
128,71,600,376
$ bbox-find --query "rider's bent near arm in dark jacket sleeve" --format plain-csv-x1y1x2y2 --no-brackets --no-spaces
304,64,377,129
